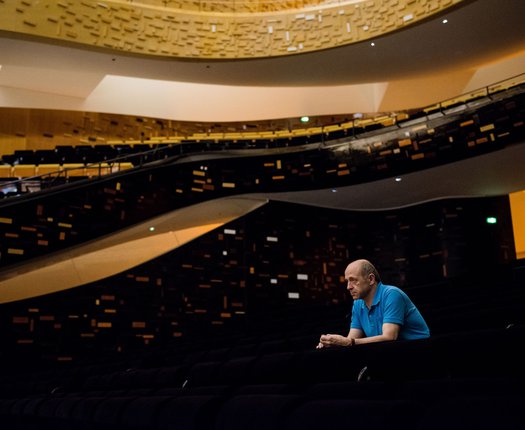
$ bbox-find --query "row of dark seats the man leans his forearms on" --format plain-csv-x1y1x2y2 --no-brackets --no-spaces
0,325,525,397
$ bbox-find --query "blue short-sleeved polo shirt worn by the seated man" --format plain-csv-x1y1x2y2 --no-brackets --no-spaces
350,282,430,340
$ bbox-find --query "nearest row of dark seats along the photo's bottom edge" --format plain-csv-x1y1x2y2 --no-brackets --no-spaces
0,378,525,430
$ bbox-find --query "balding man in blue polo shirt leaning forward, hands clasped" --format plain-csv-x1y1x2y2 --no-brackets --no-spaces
317,260,430,348
